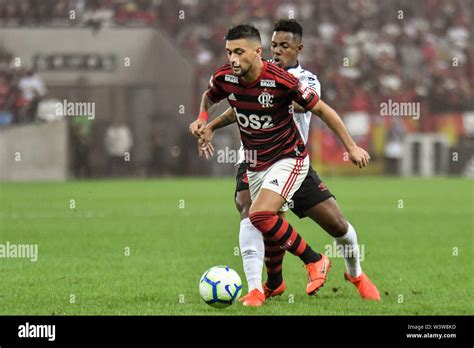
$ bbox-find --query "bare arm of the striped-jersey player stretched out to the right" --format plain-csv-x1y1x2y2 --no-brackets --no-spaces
309,100,370,168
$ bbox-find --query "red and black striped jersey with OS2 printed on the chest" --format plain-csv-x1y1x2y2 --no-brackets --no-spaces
207,61,319,171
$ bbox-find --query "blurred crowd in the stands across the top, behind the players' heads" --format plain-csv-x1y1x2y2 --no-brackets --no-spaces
0,0,474,125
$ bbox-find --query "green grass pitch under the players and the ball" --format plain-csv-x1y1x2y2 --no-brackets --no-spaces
0,177,474,315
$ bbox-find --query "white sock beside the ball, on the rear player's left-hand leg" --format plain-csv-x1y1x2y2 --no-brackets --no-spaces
239,218,265,293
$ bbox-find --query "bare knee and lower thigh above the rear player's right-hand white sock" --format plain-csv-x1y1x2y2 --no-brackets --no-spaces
305,197,348,238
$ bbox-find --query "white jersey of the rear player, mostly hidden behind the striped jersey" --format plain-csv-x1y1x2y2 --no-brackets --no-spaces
237,63,321,164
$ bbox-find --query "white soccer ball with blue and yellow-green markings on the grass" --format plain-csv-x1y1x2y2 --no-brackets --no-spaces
199,266,242,308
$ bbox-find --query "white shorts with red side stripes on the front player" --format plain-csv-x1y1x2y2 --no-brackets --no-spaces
247,156,309,211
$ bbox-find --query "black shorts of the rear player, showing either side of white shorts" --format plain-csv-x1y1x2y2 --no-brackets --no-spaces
234,164,336,219
